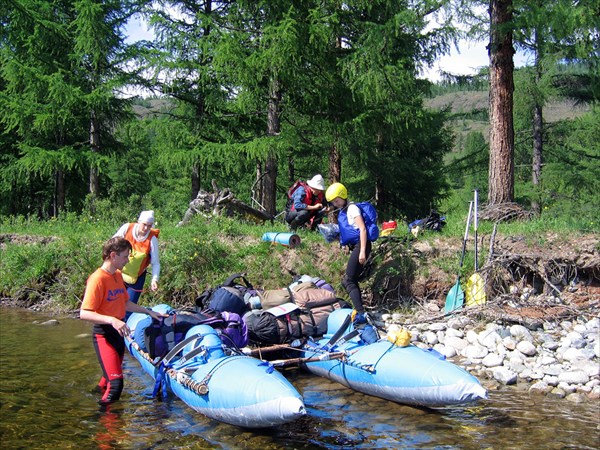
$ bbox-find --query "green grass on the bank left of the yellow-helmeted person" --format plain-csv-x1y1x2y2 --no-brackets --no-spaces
0,216,347,309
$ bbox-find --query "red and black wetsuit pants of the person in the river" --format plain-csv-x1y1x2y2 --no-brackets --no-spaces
93,325,125,404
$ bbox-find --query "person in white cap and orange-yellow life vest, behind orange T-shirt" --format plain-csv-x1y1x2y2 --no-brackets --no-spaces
113,211,160,303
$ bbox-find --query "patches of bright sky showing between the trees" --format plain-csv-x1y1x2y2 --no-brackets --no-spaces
125,17,527,82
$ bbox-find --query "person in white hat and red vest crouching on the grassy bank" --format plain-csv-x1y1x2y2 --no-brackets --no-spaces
285,174,325,231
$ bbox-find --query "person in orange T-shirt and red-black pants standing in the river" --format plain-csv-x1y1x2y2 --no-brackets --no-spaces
79,237,165,405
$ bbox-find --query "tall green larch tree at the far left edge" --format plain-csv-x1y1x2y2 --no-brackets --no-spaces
0,0,85,217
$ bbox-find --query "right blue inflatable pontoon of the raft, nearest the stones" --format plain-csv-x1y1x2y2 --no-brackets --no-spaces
296,308,487,407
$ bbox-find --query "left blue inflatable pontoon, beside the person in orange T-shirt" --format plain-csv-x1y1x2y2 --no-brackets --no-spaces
125,305,306,428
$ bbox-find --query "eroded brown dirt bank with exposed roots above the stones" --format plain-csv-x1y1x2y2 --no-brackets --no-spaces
0,232,600,326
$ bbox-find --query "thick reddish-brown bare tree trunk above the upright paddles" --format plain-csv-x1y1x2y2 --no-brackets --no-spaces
488,0,515,205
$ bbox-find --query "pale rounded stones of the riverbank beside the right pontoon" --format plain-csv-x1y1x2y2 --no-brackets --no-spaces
377,304,600,402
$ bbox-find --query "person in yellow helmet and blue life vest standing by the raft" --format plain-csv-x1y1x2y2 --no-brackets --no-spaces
325,183,379,344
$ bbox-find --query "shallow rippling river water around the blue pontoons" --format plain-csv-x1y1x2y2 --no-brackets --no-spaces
0,308,600,450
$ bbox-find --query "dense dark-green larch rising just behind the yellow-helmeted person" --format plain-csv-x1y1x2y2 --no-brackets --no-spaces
328,0,454,217
